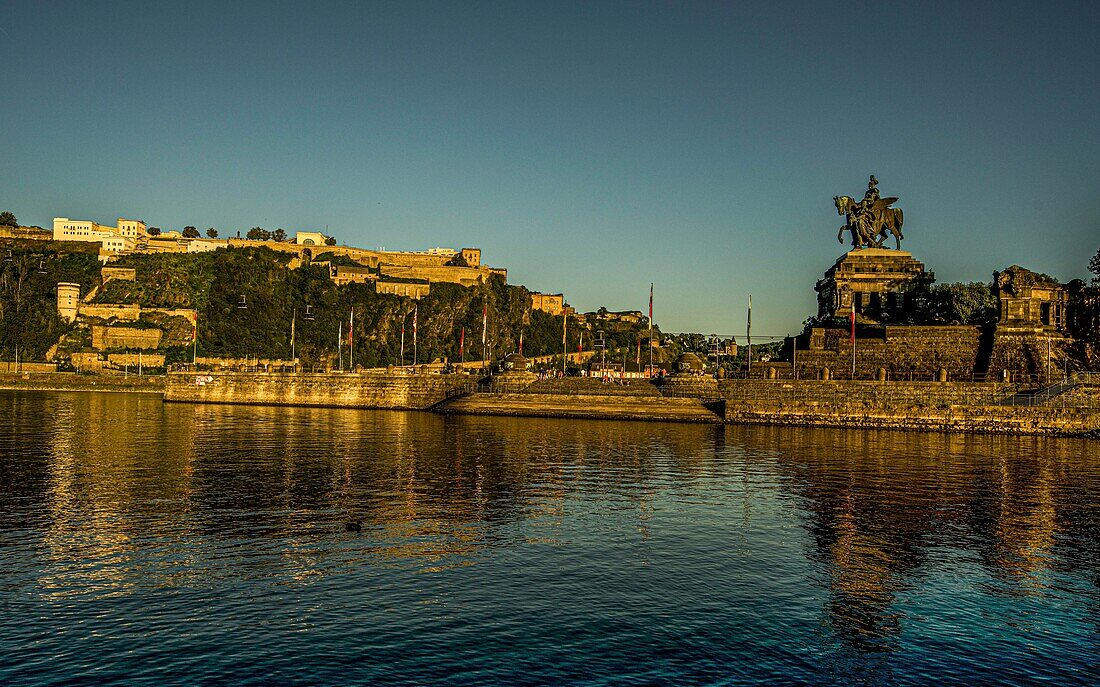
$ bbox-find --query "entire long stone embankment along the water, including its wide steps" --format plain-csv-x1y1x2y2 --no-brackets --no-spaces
155,370,1100,436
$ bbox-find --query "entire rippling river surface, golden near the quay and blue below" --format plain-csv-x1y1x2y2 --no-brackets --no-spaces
0,392,1100,685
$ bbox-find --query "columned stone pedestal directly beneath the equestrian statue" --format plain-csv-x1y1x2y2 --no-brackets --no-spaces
814,248,936,322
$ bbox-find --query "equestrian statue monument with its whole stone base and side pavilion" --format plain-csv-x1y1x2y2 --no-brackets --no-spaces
783,176,1084,381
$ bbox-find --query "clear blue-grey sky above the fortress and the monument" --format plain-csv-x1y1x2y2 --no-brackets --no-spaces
0,1,1100,334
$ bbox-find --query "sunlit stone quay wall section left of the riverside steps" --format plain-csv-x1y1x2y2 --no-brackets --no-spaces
164,372,474,410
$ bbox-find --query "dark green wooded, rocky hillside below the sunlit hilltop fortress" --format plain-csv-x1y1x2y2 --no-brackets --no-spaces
0,244,656,367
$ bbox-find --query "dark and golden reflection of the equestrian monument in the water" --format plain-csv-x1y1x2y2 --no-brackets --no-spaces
777,430,1100,651
